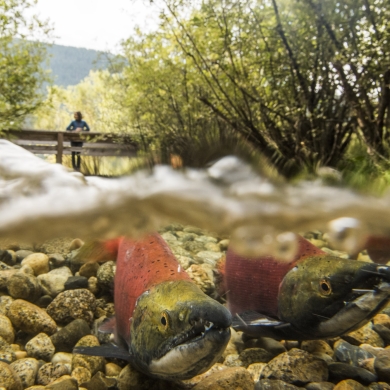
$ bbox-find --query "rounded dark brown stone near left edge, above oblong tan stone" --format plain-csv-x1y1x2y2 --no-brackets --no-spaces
7,272,42,302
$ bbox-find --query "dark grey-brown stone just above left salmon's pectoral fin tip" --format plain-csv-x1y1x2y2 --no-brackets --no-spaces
50,319,91,352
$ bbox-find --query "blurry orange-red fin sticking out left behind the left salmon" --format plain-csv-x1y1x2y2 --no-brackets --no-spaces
73,238,122,263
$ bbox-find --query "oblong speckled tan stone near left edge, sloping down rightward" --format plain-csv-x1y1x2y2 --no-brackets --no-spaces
8,299,57,335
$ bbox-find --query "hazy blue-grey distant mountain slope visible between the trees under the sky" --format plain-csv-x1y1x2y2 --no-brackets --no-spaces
44,45,112,87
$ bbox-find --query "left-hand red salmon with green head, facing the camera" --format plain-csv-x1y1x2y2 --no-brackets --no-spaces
74,234,231,379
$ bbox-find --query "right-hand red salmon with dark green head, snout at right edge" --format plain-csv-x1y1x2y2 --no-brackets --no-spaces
226,238,390,340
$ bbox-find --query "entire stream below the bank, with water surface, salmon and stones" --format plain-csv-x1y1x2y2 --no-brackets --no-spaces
0,140,390,390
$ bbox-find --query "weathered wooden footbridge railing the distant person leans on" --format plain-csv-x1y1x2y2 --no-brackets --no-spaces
1,130,138,164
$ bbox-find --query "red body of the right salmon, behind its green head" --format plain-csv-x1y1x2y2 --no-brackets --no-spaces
224,235,326,317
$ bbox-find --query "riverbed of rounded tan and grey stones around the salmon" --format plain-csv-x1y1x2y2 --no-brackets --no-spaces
0,224,390,390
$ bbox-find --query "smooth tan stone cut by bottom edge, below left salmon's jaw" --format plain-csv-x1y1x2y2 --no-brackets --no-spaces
193,367,255,390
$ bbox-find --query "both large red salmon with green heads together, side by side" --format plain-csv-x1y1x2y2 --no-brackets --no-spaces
74,233,390,379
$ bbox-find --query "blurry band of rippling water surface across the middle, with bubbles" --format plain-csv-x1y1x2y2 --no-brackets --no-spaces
0,140,390,258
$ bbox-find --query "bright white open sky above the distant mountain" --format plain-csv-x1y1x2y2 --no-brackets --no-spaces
33,0,163,52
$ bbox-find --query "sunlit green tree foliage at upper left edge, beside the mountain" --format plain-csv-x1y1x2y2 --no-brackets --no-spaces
0,0,49,129
